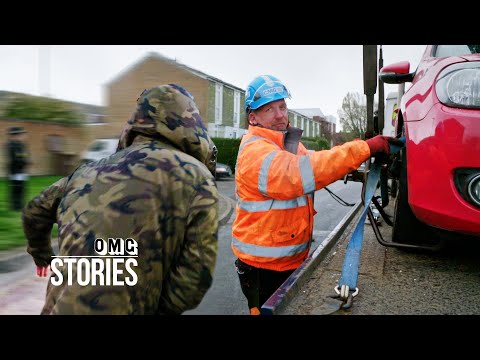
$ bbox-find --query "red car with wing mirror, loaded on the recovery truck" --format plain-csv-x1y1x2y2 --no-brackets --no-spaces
379,45,480,244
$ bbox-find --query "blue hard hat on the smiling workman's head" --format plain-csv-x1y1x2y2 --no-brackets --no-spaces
245,75,290,112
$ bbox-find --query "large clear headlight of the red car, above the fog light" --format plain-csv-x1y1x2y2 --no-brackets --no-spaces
435,62,480,109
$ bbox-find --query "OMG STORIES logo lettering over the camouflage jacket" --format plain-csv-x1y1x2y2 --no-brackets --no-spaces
50,238,138,286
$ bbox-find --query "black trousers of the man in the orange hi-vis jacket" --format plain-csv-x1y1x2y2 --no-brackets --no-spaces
235,259,295,310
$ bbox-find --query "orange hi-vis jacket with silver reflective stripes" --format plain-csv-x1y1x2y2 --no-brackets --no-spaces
231,126,370,271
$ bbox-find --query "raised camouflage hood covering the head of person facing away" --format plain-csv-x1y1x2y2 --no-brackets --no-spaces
117,84,217,175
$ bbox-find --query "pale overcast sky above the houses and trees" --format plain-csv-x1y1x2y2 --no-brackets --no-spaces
0,45,425,118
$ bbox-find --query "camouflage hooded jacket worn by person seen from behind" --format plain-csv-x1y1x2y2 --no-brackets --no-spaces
22,84,218,314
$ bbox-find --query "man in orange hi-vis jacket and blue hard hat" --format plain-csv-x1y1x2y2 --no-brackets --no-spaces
231,75,399,315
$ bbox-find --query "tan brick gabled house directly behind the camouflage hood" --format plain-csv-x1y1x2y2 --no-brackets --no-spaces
102,53,246,138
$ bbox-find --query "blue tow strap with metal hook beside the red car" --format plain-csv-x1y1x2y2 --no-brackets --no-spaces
338,137,405,298
